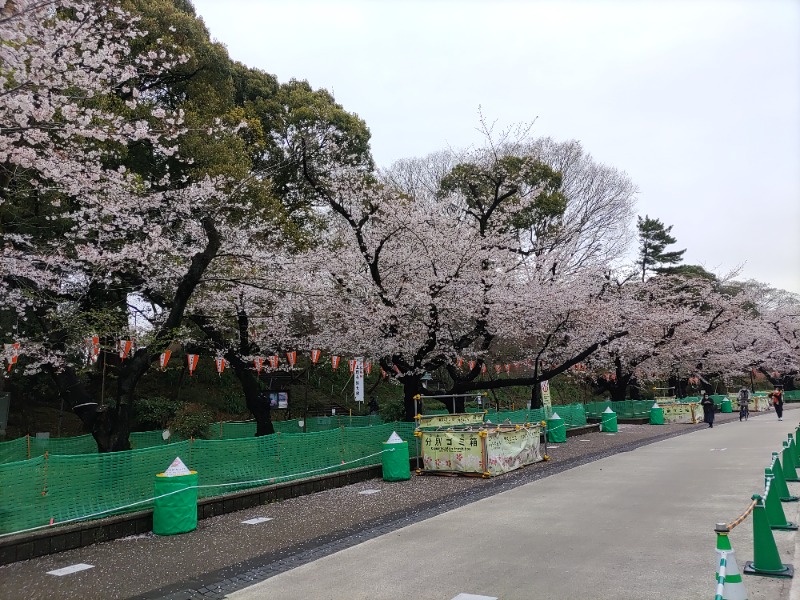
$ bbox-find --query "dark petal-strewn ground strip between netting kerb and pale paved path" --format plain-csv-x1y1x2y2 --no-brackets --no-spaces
0,413,774,600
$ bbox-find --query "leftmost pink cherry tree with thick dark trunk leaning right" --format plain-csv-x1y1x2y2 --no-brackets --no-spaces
0,0,278,450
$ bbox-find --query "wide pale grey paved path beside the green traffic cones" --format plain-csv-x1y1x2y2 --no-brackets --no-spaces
227,411,800,600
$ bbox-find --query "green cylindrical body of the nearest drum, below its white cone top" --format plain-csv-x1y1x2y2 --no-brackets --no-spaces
153,471,197,535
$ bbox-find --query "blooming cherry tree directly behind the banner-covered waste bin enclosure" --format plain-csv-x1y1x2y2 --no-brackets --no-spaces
290,122,634,419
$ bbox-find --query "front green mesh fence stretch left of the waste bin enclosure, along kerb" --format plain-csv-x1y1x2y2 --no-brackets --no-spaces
0,421,414,534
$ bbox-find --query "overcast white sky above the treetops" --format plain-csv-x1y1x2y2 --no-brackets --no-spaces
193,0,800,293
